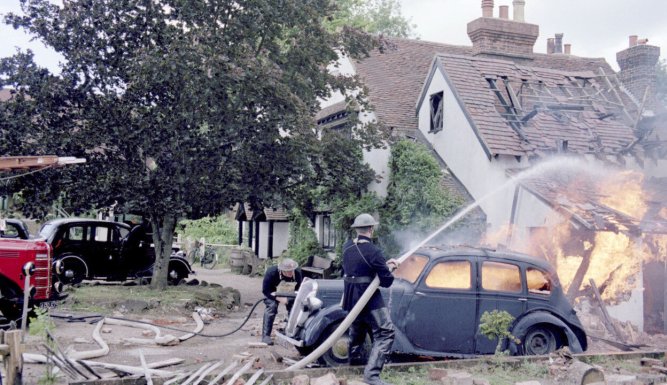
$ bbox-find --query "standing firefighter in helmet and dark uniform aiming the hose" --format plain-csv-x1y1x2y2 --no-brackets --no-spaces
343,214,398,385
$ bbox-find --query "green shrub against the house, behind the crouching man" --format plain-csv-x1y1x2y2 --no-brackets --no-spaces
282,209,325,266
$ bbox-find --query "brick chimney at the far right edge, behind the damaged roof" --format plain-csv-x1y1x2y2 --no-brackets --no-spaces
616,35,660,110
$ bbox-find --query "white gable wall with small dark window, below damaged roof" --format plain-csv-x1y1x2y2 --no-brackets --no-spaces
418,64,527,230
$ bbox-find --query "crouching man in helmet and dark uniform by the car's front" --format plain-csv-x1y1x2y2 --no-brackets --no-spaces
262,258,303,345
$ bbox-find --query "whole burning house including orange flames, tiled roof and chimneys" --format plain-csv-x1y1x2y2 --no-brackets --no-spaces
320,0,667,330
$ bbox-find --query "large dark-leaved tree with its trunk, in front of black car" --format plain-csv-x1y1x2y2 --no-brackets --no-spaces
0,0,384,288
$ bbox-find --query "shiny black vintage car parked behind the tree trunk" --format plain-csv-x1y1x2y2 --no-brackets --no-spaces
39,218,193,284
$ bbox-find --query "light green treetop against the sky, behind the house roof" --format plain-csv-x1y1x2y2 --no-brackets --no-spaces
328,0,414,37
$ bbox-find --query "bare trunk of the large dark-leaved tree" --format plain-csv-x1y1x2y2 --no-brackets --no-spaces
151,215,176,290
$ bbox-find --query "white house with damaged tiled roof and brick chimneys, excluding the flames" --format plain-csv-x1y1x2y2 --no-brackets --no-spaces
325,0,667,328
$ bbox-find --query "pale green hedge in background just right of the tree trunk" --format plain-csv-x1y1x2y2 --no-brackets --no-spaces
176,215,238,245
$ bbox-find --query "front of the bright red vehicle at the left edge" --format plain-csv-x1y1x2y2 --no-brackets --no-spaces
0,239,62,320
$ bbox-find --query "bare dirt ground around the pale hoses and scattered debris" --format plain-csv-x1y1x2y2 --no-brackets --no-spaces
10,269,667,384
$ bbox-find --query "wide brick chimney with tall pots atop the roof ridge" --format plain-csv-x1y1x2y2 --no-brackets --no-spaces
468,0,540,58
